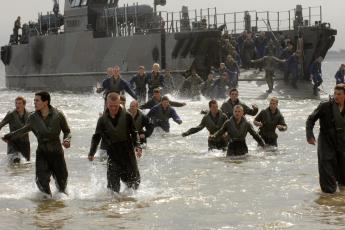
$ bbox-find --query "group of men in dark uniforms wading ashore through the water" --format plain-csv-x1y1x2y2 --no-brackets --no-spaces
0,64,345,196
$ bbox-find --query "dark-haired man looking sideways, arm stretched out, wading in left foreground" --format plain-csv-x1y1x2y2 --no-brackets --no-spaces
3,91,71,196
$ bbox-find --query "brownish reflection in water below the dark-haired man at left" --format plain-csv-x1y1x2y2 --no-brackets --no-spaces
33,200,72,229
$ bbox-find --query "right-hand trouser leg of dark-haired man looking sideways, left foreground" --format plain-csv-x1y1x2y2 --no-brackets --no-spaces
50,153,68,193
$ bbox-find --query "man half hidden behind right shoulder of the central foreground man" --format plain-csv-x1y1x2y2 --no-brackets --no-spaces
128,101,154,144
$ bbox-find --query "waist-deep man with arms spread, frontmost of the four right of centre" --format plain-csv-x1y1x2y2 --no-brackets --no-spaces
211,105,265,156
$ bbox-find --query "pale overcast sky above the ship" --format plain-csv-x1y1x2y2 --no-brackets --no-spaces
0,0,345,50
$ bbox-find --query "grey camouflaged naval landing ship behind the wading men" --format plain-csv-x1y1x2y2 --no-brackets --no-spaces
1,0,337,91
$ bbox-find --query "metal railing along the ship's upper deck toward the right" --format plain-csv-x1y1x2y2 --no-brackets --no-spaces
160,6,322,34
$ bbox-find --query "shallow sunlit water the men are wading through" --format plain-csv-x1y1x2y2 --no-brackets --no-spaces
0,60,345,229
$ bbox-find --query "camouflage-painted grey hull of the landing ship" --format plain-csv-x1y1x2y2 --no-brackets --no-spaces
5,27,335,91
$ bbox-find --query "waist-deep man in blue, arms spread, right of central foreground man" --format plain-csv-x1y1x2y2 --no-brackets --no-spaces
147,96,182,133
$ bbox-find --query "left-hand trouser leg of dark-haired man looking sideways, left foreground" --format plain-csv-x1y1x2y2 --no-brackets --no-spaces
36,152,51,195
